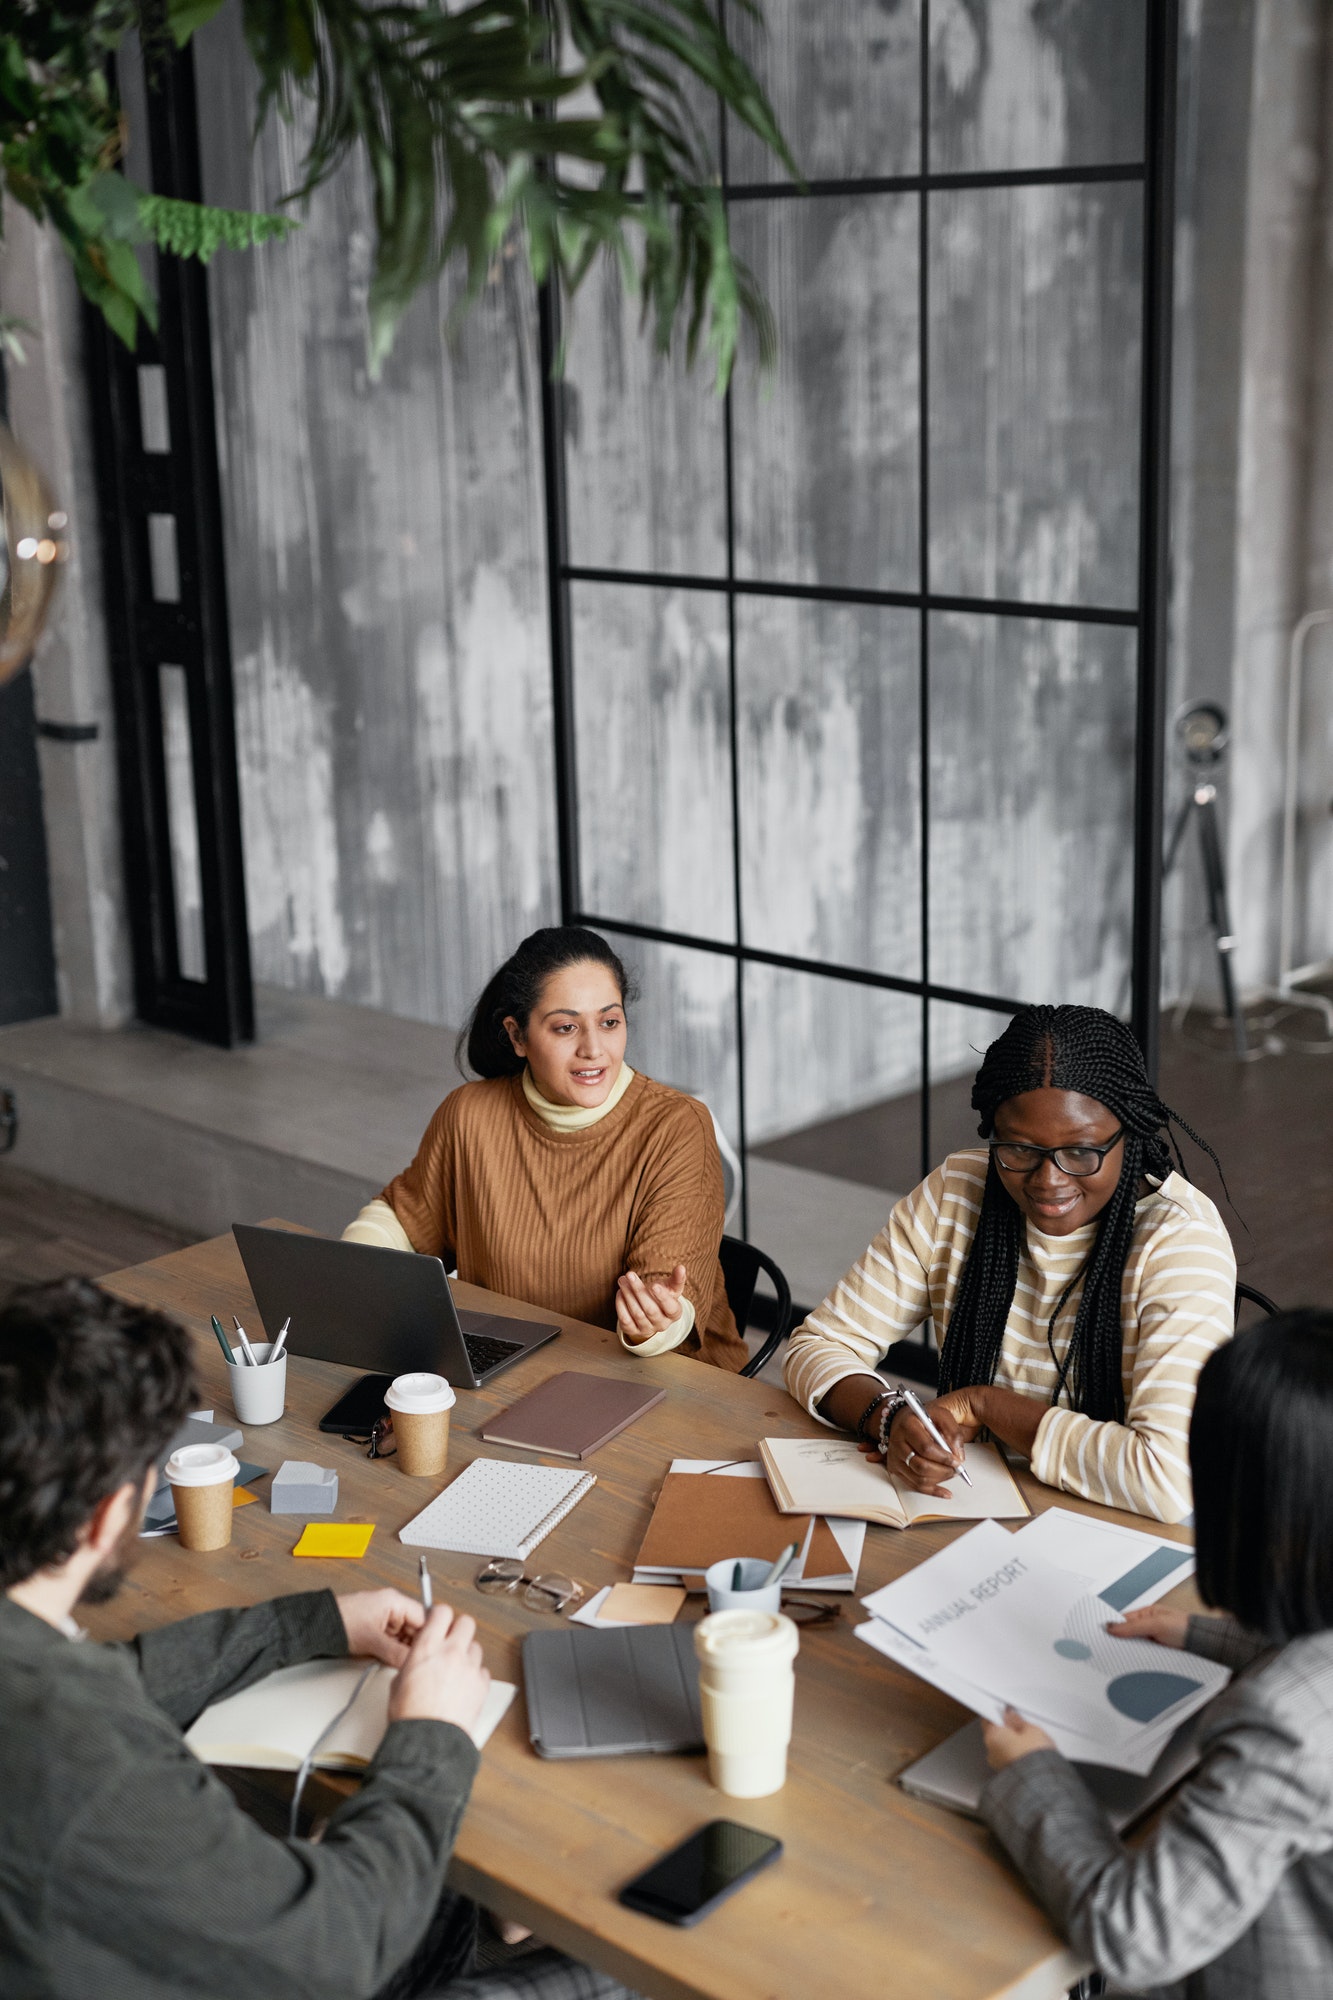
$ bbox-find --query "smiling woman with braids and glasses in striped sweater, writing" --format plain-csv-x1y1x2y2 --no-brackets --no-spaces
787,1006,1235,1520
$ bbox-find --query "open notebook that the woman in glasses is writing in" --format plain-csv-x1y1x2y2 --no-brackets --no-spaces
759,1438,1029,1528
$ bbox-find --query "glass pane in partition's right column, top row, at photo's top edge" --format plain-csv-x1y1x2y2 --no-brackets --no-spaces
931,0,1145,174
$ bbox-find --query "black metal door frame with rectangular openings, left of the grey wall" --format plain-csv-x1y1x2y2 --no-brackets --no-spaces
86,48,254,1046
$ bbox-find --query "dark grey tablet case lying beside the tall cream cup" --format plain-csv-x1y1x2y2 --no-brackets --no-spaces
522,1624,705,1758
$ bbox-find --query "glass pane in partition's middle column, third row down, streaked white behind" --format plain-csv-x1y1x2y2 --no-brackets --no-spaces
737,598,921,978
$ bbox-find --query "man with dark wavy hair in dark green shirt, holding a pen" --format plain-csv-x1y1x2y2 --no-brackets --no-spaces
0,1280,632,2000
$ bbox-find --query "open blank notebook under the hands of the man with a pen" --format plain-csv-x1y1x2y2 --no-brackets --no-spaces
186,1660,516,1770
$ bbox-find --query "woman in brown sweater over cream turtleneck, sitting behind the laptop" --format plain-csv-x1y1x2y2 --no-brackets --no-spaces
342,924,749,1372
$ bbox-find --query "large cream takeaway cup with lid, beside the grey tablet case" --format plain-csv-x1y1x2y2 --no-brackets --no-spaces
695,1610,801,1798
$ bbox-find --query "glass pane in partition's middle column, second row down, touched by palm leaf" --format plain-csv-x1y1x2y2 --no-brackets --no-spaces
731,194,919,590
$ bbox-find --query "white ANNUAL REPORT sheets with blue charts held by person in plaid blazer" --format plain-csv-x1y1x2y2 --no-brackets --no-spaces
857,1522,1231,1774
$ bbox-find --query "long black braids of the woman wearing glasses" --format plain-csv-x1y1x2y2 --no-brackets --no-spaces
939,1006,1225,1422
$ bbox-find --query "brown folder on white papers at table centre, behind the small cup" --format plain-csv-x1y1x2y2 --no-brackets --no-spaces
634,1458,865,1590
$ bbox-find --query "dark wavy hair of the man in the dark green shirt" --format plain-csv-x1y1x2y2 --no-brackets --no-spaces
0,1278,196,1590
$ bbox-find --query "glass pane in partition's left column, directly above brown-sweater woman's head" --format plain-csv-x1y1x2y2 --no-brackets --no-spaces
570,584,737,942
